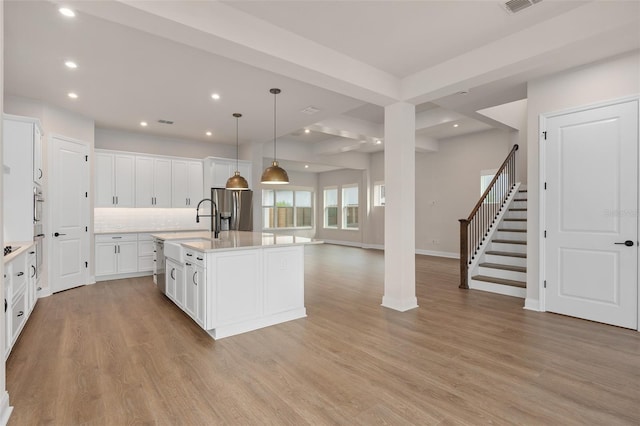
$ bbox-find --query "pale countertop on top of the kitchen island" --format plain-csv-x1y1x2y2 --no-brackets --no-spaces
152,231,323,252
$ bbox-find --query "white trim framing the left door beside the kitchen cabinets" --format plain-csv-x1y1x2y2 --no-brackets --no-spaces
43,133,95,296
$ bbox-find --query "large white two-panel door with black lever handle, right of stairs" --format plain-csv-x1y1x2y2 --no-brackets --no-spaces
543,101,638,329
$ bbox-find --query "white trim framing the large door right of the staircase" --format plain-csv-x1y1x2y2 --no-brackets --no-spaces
538,94,640,332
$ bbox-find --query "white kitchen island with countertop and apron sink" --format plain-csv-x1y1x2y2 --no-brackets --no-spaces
152,231,321,339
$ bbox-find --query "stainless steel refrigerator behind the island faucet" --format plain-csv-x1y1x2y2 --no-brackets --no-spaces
211,188,253,231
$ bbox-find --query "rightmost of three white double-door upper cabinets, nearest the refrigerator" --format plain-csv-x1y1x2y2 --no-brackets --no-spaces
171,160,204,207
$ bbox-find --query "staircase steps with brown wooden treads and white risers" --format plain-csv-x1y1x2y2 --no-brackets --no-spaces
469,186,527,298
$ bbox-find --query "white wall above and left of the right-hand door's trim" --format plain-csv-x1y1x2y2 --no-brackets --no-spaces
525,51,640,309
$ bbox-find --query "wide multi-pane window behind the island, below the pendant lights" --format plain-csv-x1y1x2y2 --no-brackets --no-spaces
262,189,313,229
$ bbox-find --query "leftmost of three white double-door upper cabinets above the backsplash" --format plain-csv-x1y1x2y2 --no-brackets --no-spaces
95,150,135,207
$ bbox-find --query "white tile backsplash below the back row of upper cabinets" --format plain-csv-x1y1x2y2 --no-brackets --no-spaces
93,208,209,233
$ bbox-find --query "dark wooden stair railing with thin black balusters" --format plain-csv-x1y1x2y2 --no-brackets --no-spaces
459,144,518,289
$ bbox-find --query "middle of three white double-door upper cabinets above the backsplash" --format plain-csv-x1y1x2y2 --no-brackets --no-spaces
136,156,171,207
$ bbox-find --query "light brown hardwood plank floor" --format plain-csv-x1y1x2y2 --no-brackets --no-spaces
7,245,640,425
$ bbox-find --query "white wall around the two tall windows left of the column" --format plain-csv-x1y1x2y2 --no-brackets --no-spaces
316,169,367,247
